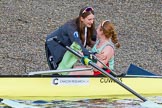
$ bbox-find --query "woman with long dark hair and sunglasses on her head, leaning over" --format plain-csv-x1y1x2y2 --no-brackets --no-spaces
45,7,96,70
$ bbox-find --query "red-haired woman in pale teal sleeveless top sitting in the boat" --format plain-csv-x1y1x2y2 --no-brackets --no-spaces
69,20,120,76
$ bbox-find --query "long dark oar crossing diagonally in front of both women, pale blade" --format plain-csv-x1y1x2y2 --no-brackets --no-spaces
52,36,162,108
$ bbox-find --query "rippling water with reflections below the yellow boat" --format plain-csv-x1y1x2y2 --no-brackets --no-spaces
0,96,162,108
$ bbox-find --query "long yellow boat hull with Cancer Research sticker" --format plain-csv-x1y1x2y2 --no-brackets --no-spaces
0,77,162,99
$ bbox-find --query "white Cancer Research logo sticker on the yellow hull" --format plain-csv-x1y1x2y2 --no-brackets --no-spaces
52,78,90,85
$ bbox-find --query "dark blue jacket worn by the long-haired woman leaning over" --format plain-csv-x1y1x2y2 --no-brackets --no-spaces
46,19,96,63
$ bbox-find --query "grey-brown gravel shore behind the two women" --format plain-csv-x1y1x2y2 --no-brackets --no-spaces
0,0,162,75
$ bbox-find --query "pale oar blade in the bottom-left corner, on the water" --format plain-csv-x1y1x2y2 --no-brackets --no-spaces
0,98,38,108
